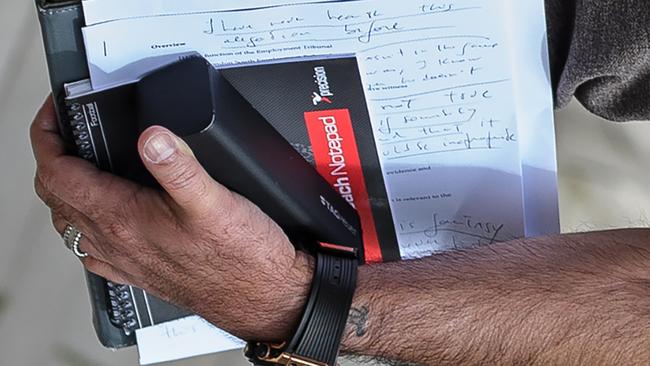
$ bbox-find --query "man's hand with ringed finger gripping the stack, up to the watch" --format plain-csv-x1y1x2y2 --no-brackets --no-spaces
31,99,311,340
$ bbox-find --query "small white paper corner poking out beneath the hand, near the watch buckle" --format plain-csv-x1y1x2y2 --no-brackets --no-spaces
136,316,245,365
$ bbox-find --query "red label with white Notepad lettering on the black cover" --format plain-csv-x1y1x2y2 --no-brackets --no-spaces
305,109,382,263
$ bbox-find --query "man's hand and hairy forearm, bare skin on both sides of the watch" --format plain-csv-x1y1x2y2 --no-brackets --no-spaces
32,96,650,365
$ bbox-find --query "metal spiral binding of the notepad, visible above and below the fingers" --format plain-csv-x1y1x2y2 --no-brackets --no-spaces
68,103,138,336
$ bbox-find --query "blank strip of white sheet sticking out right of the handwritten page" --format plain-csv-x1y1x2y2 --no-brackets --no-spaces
507,0,560,236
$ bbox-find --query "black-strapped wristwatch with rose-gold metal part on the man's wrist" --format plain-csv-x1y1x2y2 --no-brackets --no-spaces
245,243,359,366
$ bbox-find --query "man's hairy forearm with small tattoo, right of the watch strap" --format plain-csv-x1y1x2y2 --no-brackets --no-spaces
343,231,650,365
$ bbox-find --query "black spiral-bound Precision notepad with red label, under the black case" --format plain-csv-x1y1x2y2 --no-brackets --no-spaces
59,56,400,346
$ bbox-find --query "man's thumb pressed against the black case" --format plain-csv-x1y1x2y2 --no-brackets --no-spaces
138,126,230,217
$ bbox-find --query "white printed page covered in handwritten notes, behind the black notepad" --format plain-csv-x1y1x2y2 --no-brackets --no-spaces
84,0,541,258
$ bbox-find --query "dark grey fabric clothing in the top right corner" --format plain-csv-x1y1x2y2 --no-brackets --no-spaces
546,0,650,121
